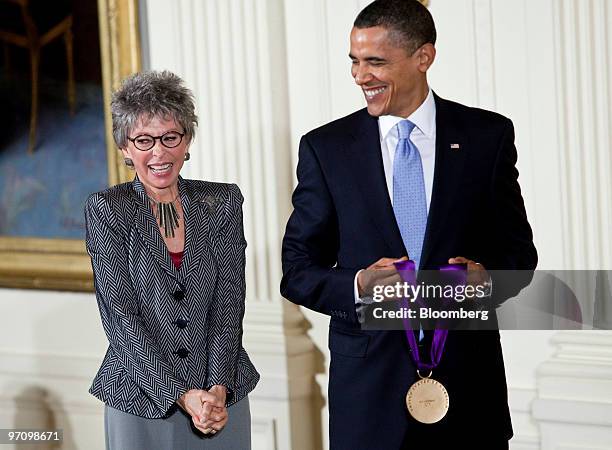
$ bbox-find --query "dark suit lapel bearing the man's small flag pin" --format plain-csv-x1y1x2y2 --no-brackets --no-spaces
420,94,469,268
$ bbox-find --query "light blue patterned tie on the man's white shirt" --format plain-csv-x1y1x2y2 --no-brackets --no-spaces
393,120,427,270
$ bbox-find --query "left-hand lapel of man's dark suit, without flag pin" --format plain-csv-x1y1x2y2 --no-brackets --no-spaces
347,110,406,257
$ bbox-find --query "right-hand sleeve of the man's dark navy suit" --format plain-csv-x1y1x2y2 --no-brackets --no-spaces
483,120,538,303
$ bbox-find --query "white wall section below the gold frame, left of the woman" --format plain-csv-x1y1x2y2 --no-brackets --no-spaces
0,289,106,449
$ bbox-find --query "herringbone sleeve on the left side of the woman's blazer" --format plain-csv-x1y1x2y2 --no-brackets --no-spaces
85,194,188,415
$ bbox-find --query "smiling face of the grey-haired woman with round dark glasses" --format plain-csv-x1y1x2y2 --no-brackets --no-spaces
121,117,189,193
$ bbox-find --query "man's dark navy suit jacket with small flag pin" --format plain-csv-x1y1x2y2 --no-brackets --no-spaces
281,96,537,450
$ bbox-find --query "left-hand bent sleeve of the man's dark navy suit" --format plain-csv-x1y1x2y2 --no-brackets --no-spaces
281,136,357,322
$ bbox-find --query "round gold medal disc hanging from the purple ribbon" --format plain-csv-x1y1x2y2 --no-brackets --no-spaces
406,378,449,423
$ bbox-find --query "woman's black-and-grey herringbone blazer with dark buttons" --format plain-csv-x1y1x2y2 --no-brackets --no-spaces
85,178,259,418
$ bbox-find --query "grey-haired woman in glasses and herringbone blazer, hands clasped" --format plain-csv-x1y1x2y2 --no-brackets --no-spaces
85,71,259,450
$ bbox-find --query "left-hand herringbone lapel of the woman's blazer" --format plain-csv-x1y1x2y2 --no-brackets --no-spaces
132,177,178,279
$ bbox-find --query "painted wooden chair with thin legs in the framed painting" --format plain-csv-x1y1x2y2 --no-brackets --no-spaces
0,0,76,153
